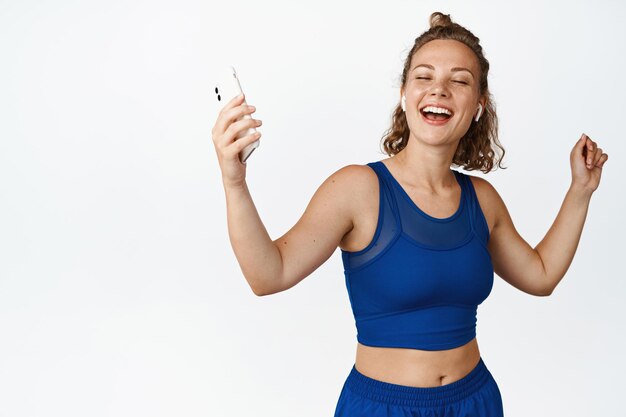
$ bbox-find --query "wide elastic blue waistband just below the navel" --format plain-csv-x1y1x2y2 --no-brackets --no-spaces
346,357,492,407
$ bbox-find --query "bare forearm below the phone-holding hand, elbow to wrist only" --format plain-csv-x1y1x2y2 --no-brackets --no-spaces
224,182,282,294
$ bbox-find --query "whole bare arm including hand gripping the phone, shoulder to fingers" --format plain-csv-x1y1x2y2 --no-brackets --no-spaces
212,94,354,295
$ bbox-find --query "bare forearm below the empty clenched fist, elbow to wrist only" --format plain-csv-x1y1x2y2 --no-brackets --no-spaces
535,185,592,293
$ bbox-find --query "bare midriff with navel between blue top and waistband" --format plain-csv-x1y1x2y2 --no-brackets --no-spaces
355,338,480,388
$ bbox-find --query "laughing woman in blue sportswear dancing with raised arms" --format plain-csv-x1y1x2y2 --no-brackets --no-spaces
212,12,608,417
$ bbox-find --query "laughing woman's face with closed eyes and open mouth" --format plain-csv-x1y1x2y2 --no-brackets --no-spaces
401,39,485,143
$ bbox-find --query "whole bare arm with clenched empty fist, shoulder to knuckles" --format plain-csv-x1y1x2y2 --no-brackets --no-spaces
480,136,608,296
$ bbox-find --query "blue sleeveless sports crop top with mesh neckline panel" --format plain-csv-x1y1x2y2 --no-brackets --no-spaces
341,161,494,350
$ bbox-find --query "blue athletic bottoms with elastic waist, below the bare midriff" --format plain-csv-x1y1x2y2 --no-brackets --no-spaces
334,357,504,417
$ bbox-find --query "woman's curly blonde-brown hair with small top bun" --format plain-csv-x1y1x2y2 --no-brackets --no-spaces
382,12,506,174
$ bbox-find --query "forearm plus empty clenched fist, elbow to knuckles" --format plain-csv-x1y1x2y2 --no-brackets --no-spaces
535,133,609,293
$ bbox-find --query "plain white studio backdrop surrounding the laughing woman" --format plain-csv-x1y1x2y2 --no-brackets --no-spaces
0,0,626,417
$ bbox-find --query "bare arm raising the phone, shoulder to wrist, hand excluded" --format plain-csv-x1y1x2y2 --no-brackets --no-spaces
225,165,360,296
